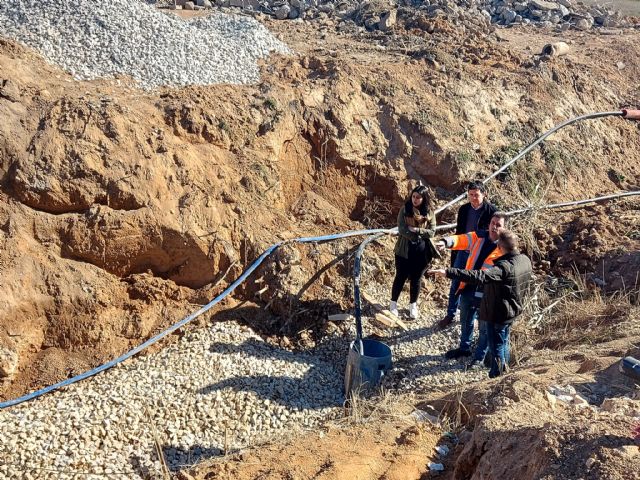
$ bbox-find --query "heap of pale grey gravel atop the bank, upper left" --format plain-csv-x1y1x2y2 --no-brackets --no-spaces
0,0,288,88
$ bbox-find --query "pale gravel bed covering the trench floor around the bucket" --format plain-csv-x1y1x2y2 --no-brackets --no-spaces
0,300,486,480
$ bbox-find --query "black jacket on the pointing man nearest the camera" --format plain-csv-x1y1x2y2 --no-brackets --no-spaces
447,253,531,325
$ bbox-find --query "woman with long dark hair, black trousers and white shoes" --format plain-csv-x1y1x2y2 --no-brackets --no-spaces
389,185,436,318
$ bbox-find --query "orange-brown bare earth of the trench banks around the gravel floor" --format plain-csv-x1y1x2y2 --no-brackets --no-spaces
0,2,640,480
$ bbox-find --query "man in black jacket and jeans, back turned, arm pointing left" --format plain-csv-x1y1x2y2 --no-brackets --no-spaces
429,230,532,378
